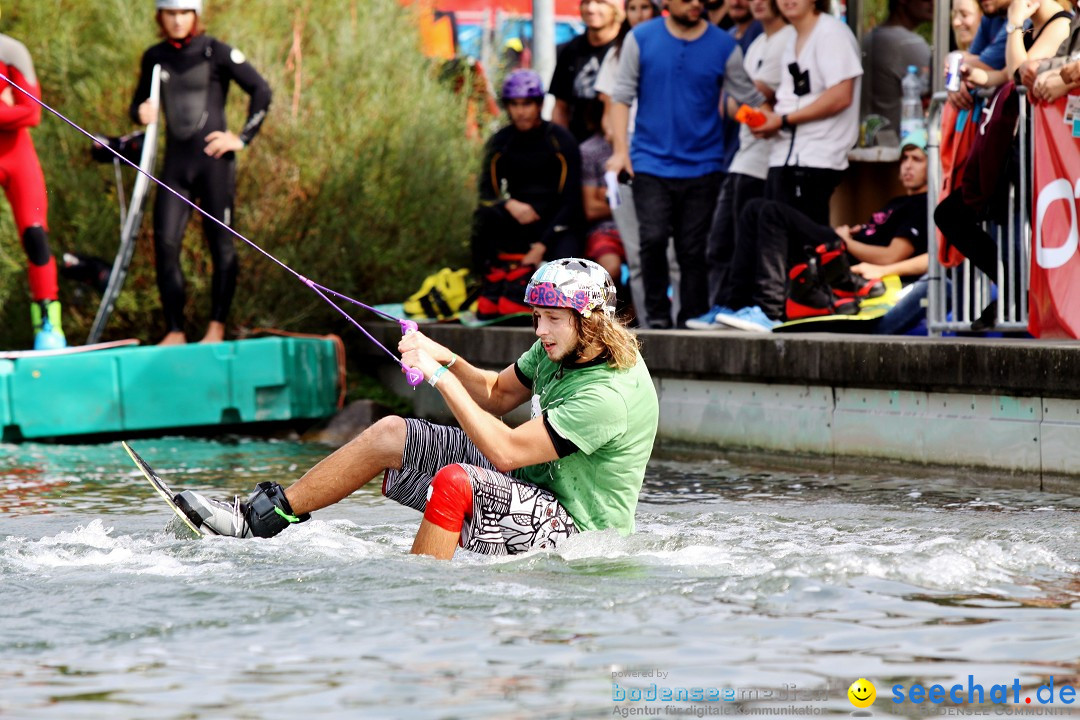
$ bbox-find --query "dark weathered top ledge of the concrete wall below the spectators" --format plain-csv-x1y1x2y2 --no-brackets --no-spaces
360,323,1080,398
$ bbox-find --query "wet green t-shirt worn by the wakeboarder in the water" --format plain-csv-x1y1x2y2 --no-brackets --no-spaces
517,340,660,534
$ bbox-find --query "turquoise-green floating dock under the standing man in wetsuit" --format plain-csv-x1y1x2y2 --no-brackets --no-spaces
0,337,343,443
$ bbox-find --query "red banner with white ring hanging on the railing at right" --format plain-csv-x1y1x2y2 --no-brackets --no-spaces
1027,96,1080,338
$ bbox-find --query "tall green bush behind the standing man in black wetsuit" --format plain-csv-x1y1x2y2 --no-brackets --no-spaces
0,0,481,347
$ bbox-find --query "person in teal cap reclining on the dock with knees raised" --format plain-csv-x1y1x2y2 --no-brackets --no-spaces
716,132,927,330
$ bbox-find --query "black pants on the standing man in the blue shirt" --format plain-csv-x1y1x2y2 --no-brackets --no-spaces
634,173,724,327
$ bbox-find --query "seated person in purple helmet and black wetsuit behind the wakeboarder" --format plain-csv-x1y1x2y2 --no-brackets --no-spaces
472,70,584,317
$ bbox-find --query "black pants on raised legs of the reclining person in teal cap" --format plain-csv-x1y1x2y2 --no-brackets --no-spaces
725,199,836,320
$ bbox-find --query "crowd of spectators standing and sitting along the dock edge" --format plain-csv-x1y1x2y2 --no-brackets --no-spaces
473,0,1080,332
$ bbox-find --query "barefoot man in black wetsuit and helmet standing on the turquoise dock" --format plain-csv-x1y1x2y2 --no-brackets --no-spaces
131,0,270,344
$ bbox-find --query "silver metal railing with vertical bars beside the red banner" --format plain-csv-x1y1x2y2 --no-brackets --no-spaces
927,86,1031,335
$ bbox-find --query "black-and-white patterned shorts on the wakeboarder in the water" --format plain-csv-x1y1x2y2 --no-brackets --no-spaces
382,419,578,555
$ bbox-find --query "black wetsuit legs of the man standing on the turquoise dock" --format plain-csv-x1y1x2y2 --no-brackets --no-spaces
153,151,238,332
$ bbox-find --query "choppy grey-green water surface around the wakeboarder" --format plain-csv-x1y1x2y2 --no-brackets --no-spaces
0,438,1080,719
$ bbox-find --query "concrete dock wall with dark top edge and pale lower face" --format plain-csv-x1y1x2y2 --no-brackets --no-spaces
353,325,1080,487
